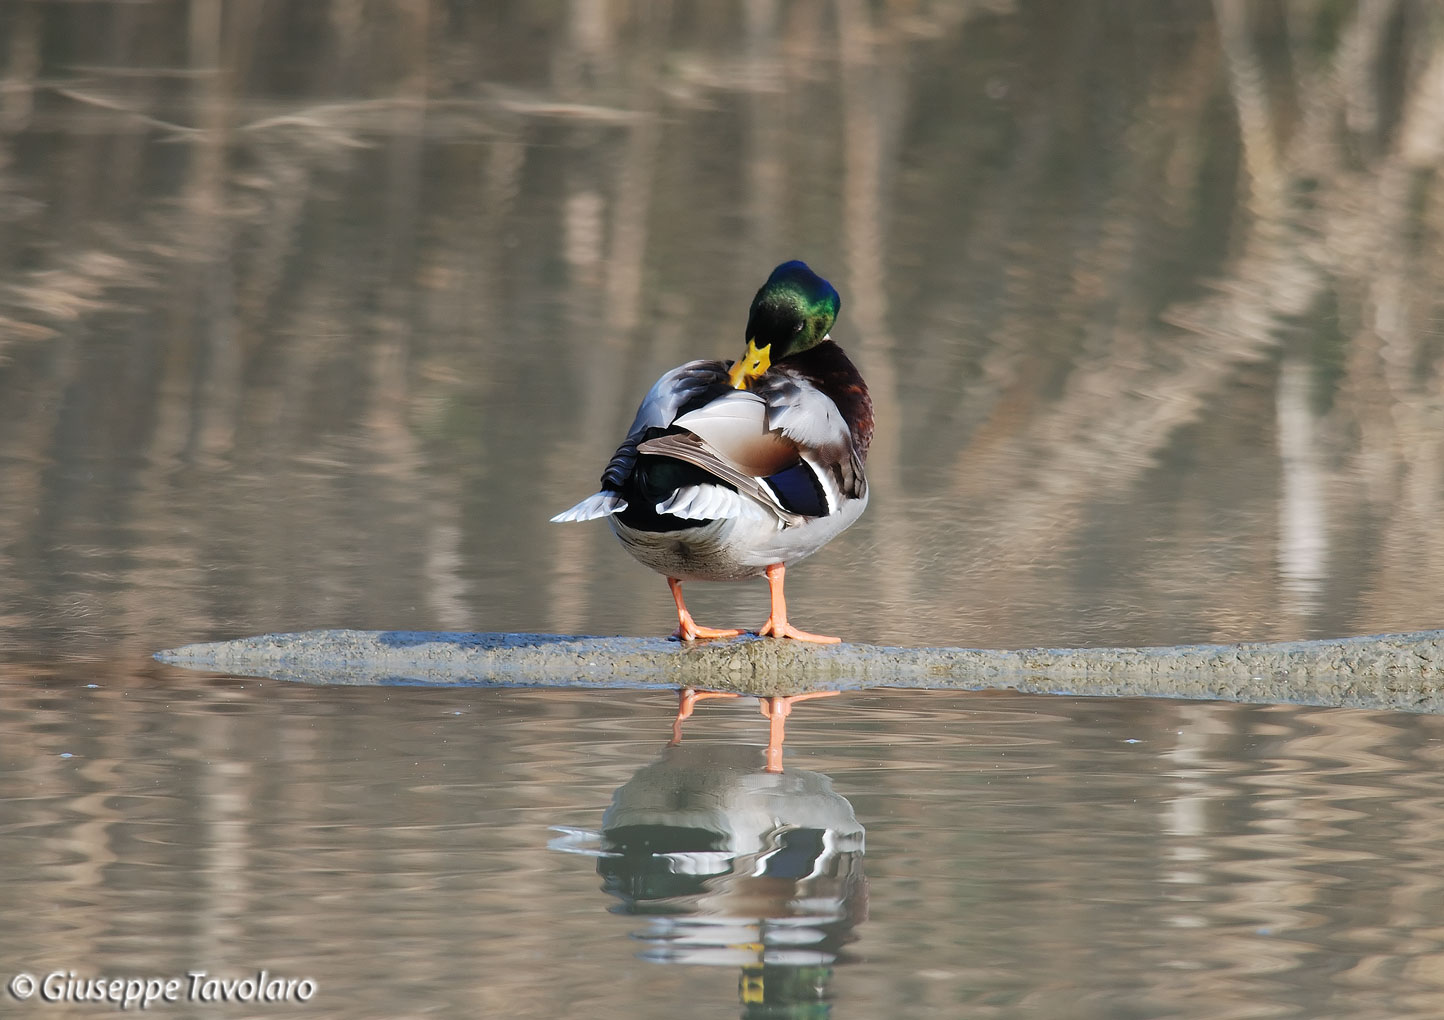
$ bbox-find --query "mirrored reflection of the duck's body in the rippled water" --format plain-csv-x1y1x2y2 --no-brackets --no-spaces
557,744,868,1017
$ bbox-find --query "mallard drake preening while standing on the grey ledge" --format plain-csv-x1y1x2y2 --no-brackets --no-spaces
552,262,872,643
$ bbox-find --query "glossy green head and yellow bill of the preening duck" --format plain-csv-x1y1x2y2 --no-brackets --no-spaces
731,262,842,390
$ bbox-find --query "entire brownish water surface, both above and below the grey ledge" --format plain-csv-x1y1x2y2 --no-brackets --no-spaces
0,0,1444,1020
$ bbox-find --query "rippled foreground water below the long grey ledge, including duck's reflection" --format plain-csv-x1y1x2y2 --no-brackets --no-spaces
0,672,1444,1017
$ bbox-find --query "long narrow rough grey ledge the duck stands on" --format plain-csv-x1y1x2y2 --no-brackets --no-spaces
156,630,1444,712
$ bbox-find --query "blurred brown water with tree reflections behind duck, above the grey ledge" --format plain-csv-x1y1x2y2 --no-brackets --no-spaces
0,0,1444,650
